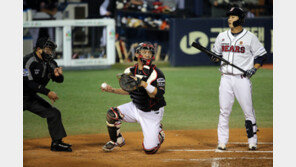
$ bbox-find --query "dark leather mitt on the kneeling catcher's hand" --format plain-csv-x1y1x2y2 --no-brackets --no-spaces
117,73,141,92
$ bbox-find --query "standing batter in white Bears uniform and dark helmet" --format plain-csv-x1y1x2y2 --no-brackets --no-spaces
211,7,267,150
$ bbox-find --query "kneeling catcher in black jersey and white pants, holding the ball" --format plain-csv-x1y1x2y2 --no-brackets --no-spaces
101,42,166,154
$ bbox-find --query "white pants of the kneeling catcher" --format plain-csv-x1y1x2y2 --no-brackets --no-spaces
117,102,164,150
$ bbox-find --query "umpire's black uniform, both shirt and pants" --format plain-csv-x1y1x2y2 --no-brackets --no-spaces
23,52,67,141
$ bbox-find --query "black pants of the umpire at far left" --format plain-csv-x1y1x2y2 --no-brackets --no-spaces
23,94,67,140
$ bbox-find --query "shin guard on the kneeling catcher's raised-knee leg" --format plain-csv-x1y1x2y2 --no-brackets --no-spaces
106,107,124,146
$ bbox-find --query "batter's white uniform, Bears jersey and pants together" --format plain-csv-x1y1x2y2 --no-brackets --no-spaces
212,29,266,145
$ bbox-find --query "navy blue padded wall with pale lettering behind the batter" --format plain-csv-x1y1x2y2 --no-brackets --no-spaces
169,17,273,66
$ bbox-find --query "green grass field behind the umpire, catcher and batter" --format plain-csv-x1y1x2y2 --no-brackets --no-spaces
23,65,273,139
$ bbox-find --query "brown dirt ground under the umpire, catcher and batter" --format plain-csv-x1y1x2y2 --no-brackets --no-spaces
23,128,273,167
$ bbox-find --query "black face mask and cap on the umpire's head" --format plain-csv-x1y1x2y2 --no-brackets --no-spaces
35,38,57,62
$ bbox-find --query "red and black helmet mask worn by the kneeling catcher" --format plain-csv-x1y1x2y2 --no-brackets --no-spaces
134,42,155,66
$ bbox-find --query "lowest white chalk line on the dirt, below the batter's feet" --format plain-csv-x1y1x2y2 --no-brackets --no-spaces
163,157,273,162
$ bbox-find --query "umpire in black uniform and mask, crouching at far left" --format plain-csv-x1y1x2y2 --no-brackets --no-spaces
23,38,72,152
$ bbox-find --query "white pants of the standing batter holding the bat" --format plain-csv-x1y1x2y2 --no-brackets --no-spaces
218,74,257,144
